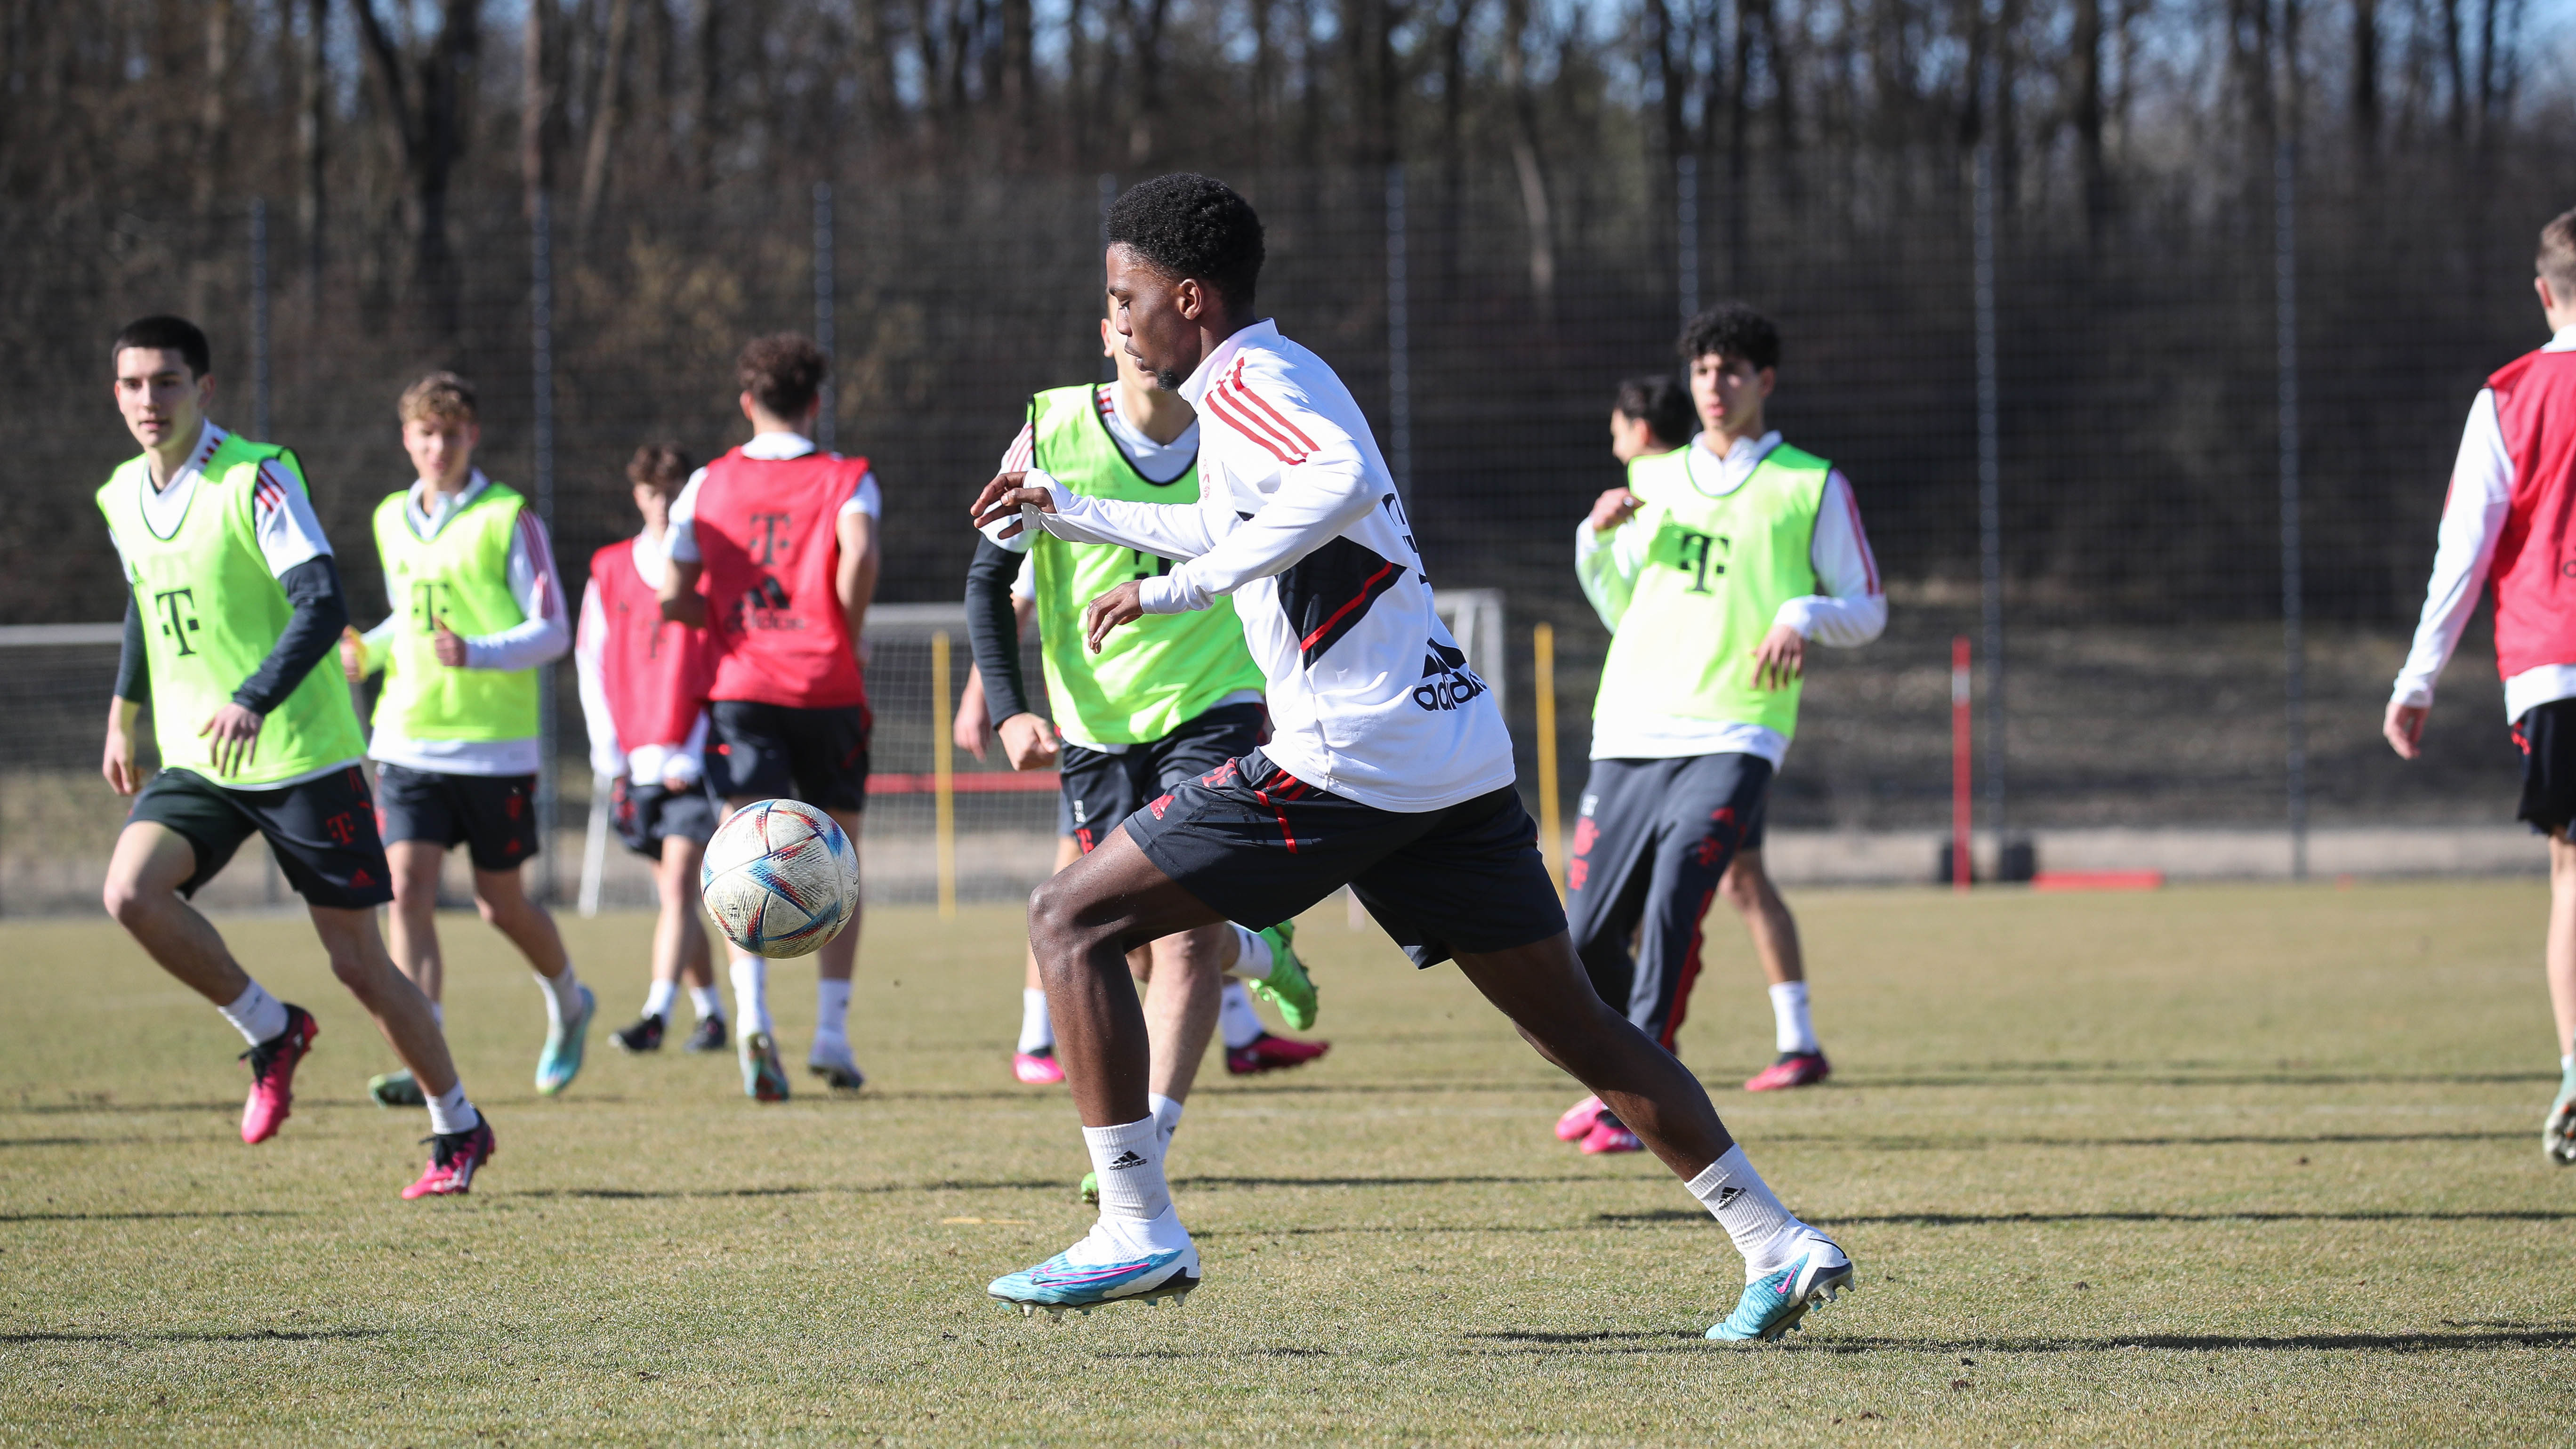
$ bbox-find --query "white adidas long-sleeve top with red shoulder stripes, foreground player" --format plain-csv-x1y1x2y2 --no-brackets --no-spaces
1022,322,1515,812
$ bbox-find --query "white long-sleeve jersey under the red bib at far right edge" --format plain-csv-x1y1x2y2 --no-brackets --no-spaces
2393,328,2576,724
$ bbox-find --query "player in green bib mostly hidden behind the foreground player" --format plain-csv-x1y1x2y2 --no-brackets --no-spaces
966,320,1329,1140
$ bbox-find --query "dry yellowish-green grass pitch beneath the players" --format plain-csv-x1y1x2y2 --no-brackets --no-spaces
0,882,2576,1444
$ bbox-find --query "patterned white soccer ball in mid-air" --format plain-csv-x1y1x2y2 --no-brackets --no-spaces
698,799,858,959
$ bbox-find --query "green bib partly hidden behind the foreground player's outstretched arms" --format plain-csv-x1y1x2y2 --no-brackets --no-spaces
1028,384,1262,745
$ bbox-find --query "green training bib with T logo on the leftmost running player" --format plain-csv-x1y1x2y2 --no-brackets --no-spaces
98,433,366,789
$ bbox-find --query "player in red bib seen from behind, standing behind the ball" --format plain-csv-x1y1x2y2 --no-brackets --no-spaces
662,333,886,1101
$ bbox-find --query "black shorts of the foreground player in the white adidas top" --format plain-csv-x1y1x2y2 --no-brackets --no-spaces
1126,750,1566,967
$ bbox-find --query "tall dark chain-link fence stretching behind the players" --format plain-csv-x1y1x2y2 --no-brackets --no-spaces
0,157,2566,902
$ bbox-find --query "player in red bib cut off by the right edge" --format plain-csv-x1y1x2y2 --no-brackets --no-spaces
2380,211,2576,1168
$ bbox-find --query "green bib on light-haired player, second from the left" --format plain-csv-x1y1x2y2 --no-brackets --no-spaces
376,482,539,740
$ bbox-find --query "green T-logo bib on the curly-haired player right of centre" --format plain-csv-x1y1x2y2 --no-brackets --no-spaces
1592,443,1834,737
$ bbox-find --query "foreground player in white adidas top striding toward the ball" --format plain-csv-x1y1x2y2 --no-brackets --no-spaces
976,175,1852,1338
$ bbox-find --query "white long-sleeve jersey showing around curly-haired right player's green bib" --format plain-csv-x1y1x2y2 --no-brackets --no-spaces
1574,433,1888,768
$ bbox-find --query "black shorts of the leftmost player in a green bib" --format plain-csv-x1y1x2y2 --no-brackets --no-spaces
126,766,394,910
